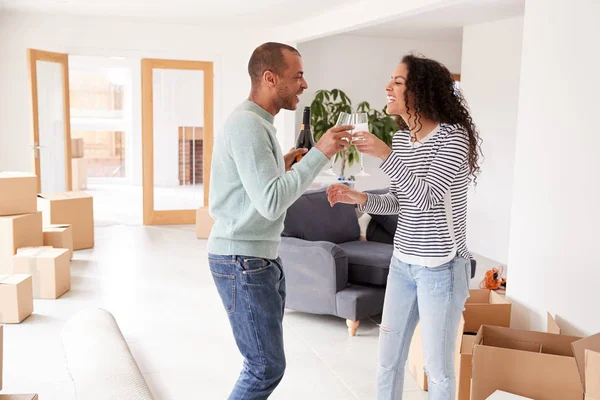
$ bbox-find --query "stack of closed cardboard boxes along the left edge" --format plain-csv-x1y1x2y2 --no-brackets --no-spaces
0,172,94,323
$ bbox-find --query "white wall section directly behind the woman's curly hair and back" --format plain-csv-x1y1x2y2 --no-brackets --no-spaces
460,17,523,265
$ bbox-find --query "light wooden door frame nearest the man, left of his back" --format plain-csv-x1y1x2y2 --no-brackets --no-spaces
142,58,214,225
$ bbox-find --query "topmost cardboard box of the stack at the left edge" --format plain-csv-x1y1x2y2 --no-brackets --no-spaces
0,172,37,215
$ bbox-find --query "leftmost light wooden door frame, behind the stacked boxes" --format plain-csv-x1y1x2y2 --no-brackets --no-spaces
27,49,72,193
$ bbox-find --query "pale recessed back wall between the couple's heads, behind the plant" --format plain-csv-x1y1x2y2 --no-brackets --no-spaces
298,35,462,190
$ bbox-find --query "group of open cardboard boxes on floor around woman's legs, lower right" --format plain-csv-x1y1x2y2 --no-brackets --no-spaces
407,290,600,400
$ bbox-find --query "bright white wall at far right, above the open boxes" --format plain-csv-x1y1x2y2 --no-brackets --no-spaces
507,0,600,334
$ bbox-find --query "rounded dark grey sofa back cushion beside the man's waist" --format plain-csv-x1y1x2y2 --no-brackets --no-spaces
281,188,360,244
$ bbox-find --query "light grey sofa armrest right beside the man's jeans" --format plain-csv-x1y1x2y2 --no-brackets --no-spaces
279,237,348,315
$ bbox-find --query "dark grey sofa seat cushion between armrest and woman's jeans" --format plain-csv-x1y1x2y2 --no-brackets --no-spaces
338,241,394,286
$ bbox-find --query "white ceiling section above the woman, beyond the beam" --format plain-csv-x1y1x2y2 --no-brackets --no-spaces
347,0,525,41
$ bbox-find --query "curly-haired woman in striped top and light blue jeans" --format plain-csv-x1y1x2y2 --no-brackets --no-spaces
328,55,480,400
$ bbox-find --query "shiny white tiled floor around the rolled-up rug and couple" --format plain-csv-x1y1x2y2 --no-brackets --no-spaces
0,225,496,400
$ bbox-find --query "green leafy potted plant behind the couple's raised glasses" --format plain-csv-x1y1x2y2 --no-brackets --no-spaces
310,89,398,177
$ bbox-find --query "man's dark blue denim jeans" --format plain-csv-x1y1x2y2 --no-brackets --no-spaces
208,254,285,400
